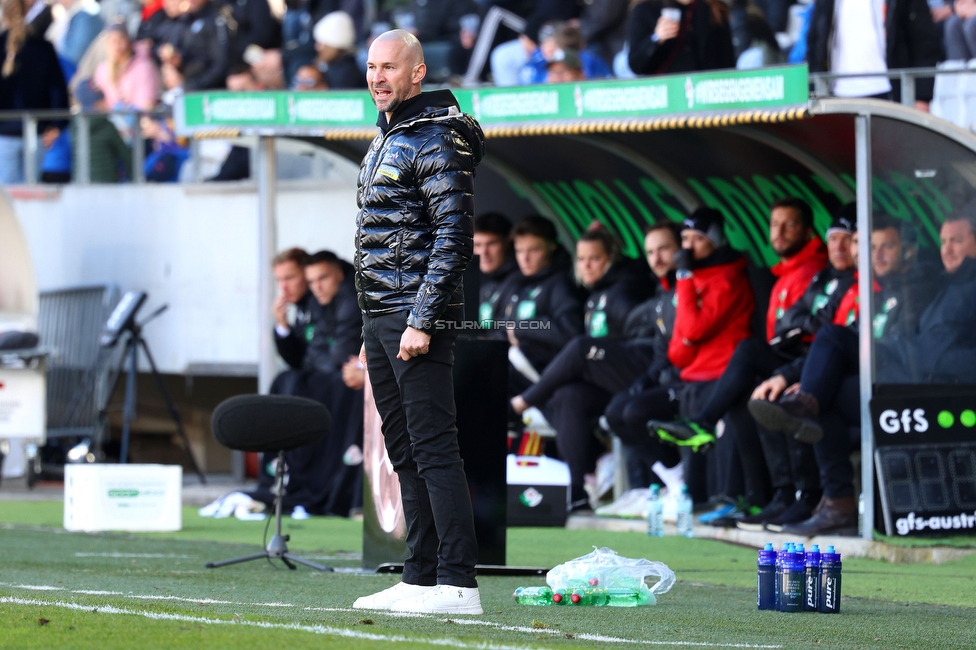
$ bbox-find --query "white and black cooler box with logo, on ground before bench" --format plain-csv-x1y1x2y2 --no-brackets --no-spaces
505,454,570,526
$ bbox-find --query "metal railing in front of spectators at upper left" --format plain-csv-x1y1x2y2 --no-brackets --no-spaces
0,108,172,185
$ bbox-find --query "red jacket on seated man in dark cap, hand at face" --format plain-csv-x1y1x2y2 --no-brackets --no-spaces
668,257,756,381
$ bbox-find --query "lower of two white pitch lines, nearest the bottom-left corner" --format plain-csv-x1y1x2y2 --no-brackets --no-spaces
0,596,533,650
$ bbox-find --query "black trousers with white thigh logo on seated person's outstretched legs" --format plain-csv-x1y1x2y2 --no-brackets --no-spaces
522,336,654,406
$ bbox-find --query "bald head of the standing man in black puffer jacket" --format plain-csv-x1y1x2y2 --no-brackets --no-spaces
366,29,427,120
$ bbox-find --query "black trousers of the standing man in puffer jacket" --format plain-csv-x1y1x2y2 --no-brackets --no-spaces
363,313,478,587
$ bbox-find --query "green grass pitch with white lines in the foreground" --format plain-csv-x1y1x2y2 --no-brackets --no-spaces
0,502,976,650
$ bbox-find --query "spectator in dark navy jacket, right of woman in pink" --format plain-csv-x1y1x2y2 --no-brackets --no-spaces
164,0,231,91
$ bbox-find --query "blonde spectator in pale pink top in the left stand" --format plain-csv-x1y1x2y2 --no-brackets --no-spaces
94,23,160,111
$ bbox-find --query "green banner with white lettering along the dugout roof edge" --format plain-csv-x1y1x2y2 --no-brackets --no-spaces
176,65,808,134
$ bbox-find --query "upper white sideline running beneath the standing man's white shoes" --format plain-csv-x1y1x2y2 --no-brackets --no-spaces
0,582,783,650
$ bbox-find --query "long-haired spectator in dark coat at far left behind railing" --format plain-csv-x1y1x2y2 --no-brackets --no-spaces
0,0,68,185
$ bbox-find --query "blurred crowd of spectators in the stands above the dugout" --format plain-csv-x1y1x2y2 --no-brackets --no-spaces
0,0,976,184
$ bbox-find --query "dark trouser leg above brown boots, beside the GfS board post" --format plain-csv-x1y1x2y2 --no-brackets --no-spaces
813,375,861,499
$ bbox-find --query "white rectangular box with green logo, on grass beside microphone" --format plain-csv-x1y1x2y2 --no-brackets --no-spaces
64,464,183,532
